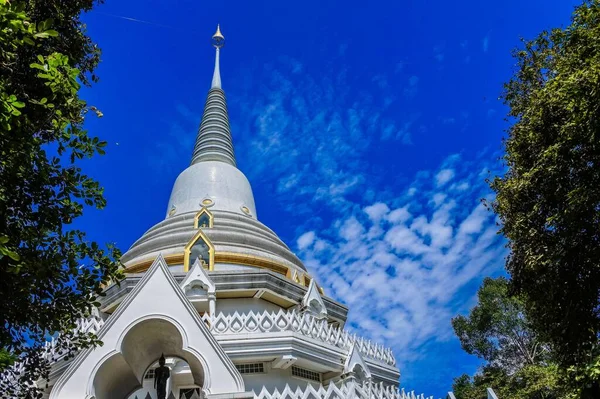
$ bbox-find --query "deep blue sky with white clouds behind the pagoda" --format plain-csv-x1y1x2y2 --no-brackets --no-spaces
78,0,577,396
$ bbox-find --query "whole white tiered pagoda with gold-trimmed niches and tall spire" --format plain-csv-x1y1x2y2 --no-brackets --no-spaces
34,24,440,399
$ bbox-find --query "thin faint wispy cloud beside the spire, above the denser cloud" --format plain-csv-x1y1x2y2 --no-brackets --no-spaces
236,59,418,212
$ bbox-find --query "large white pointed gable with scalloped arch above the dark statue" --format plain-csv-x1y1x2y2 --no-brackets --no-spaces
50,255,244,399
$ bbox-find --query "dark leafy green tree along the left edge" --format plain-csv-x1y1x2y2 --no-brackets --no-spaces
0,0,121,398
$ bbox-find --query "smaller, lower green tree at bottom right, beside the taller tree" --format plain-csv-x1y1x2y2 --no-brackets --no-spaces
452,278,563,399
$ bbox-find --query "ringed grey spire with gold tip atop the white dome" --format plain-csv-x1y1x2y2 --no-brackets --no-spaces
191,25,236,166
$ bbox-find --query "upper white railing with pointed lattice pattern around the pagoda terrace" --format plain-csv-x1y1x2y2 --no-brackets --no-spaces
202,310,396,366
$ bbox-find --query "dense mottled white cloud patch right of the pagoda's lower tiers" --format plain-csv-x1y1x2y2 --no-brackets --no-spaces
299,155,505,376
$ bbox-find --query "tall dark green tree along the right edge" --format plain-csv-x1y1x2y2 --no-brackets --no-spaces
491,0,600,397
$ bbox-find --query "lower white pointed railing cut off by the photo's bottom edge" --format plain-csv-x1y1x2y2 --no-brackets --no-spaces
254,382,433,399
